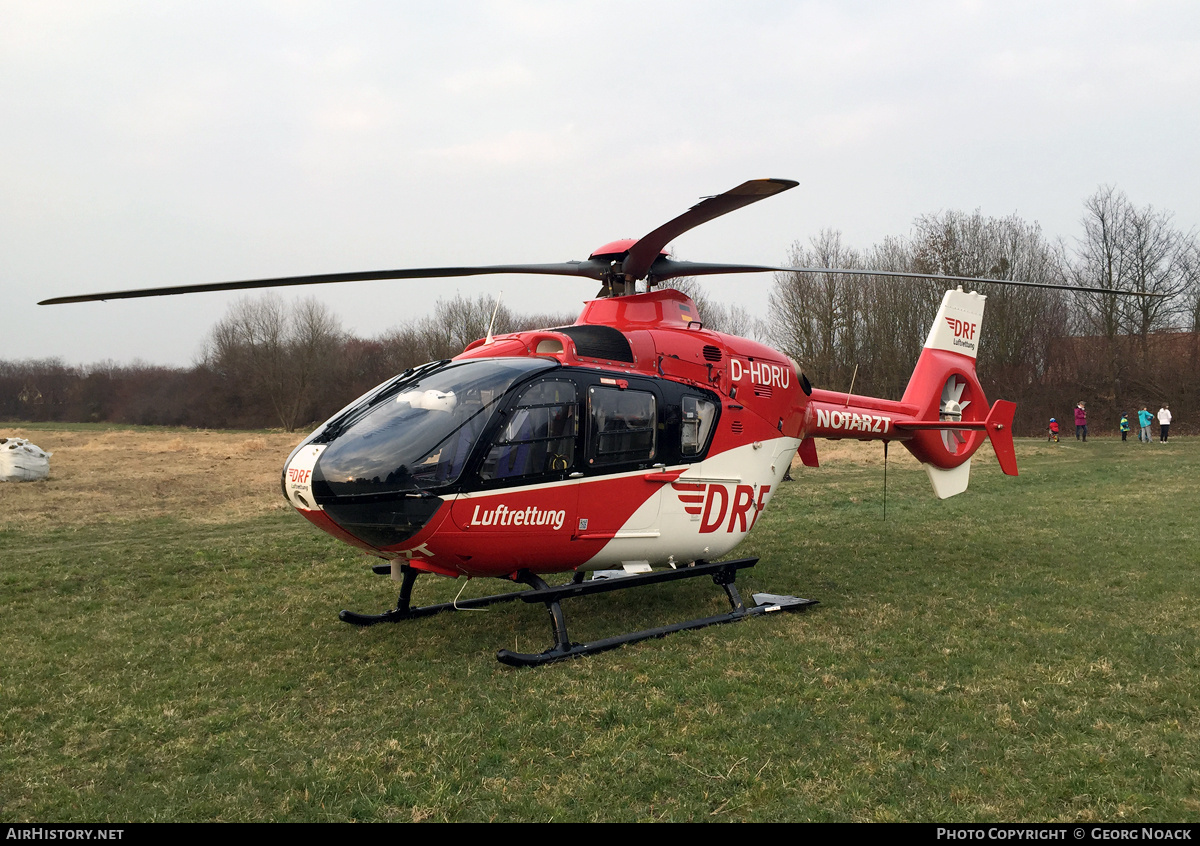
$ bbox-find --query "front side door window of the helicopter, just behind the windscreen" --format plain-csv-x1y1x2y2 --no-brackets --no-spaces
479,379,580,481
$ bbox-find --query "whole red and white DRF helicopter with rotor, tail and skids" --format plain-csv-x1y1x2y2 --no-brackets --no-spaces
42,179,1094,665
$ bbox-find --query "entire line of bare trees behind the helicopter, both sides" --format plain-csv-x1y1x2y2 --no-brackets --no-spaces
0,187,1200,434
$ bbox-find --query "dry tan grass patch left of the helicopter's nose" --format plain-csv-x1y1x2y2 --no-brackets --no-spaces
0,428,304,528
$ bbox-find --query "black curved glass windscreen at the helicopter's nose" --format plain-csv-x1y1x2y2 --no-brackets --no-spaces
313,359,558,499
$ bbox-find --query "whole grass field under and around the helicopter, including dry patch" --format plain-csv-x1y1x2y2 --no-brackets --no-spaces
0,425,1200,822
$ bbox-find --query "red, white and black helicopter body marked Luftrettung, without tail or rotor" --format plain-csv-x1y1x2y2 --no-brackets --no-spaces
283,289,808,576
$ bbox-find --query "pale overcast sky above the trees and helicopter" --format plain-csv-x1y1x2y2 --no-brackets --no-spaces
0,0,1200,365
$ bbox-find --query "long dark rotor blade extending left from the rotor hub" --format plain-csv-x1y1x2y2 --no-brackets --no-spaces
37,259,608,306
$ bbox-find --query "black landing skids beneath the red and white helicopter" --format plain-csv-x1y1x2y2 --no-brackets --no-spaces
338,558,816,667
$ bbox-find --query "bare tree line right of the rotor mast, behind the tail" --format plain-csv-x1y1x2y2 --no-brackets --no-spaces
769,187,1200,434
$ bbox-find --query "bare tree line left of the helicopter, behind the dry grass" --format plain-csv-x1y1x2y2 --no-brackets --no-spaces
0,293,577,432
